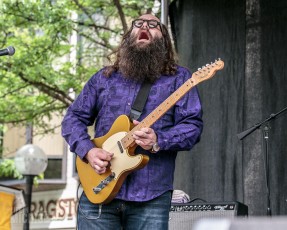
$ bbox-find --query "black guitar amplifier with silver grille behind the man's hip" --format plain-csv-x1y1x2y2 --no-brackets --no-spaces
169,201,248,230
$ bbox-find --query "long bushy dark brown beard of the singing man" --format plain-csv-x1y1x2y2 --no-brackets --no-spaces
119,33,167,82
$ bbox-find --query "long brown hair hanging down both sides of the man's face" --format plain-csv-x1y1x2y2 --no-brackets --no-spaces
104,21,176,77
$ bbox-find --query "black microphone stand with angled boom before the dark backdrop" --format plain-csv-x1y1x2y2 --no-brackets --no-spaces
237,107,287,216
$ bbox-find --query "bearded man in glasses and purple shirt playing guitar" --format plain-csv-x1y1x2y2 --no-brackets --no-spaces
62,14,203,230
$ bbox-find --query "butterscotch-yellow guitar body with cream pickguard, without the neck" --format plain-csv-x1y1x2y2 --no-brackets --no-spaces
76,115,149,204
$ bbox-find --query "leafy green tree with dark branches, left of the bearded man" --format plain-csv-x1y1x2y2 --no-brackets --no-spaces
0,0,159,133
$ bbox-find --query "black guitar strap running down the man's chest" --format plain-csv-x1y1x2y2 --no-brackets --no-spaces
130,81,152,121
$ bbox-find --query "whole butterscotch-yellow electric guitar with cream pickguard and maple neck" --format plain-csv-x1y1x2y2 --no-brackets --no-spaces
76,59,224,204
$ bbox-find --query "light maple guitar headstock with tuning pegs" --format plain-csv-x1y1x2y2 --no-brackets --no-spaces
192,58,224,83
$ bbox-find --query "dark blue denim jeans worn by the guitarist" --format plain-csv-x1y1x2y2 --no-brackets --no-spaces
77,192,171,230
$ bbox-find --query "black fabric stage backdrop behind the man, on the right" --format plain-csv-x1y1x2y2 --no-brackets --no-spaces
169,0,287,215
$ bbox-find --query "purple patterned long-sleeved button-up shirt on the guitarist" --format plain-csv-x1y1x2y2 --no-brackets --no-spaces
62,66,203,201
